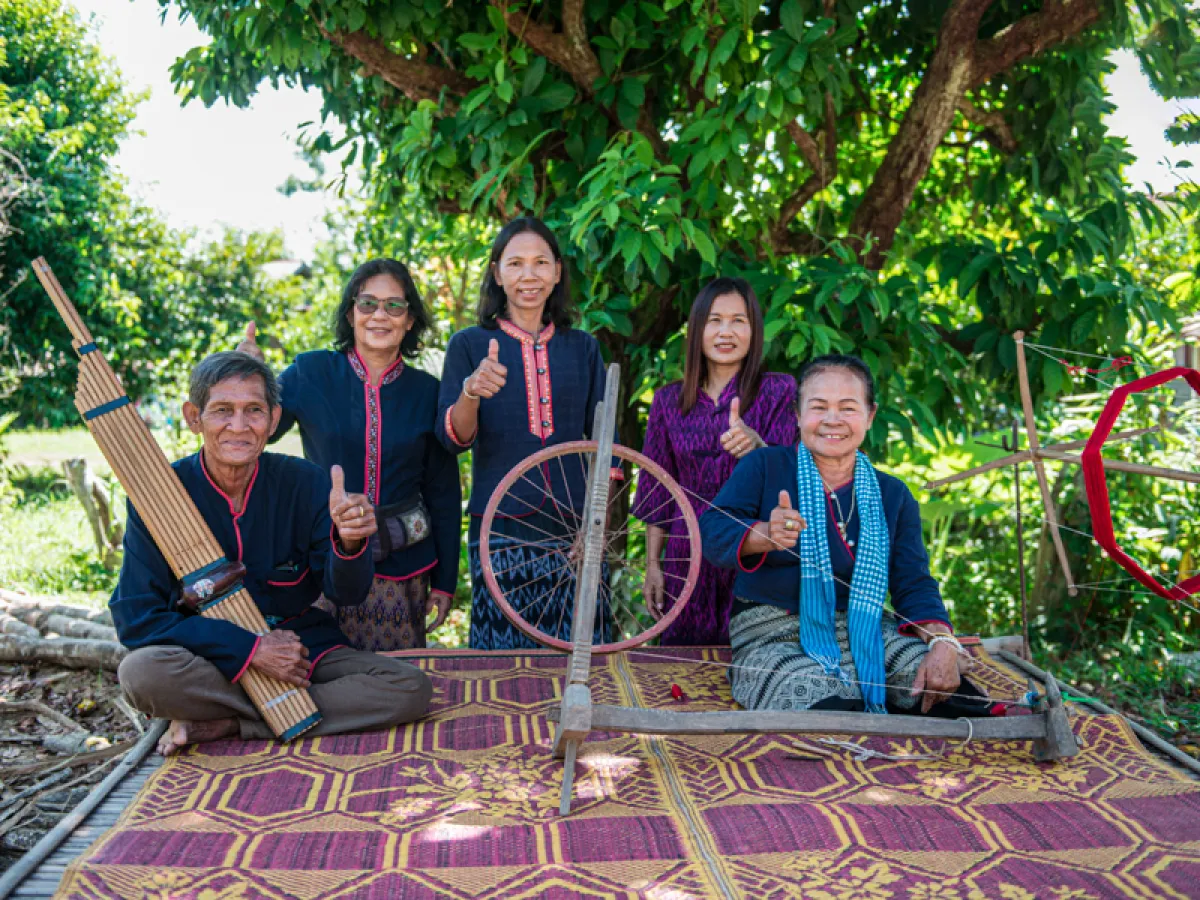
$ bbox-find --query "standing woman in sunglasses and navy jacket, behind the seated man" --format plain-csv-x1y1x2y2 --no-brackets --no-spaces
238,259,462,650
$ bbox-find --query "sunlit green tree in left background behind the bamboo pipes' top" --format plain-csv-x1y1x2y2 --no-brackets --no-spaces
0,0,314,425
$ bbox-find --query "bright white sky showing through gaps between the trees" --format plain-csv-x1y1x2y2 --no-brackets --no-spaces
73,0,1200,258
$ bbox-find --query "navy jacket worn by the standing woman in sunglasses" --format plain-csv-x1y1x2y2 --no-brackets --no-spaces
271,350,462,595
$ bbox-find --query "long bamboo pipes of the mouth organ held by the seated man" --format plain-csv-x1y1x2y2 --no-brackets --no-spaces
34,257,320,740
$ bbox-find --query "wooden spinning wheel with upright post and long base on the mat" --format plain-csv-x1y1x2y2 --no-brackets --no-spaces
480,365,1079,816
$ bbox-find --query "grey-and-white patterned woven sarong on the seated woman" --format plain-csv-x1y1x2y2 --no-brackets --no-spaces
730,604,929,710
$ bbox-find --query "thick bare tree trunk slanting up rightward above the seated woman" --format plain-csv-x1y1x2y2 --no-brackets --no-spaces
850,0,988,269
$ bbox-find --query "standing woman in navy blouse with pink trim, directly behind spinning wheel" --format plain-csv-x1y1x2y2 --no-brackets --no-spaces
437,217,608,649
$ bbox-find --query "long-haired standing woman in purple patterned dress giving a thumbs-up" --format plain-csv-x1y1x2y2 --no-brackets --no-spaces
632,278,796,646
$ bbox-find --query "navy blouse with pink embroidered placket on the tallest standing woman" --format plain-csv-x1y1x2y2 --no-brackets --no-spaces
437,319,605,517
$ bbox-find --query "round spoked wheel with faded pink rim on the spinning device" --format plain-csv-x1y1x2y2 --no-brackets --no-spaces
479,440,701,653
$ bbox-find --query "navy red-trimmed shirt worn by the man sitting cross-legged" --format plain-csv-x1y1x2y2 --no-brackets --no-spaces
109,451,374,682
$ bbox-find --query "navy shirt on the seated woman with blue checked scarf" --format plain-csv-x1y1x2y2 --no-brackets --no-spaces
700,446,950,628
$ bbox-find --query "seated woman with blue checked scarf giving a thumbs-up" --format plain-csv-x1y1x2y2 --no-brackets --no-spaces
700,355,1003,716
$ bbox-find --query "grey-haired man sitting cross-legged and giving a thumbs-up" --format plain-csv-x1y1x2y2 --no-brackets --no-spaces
110,353,432,755
